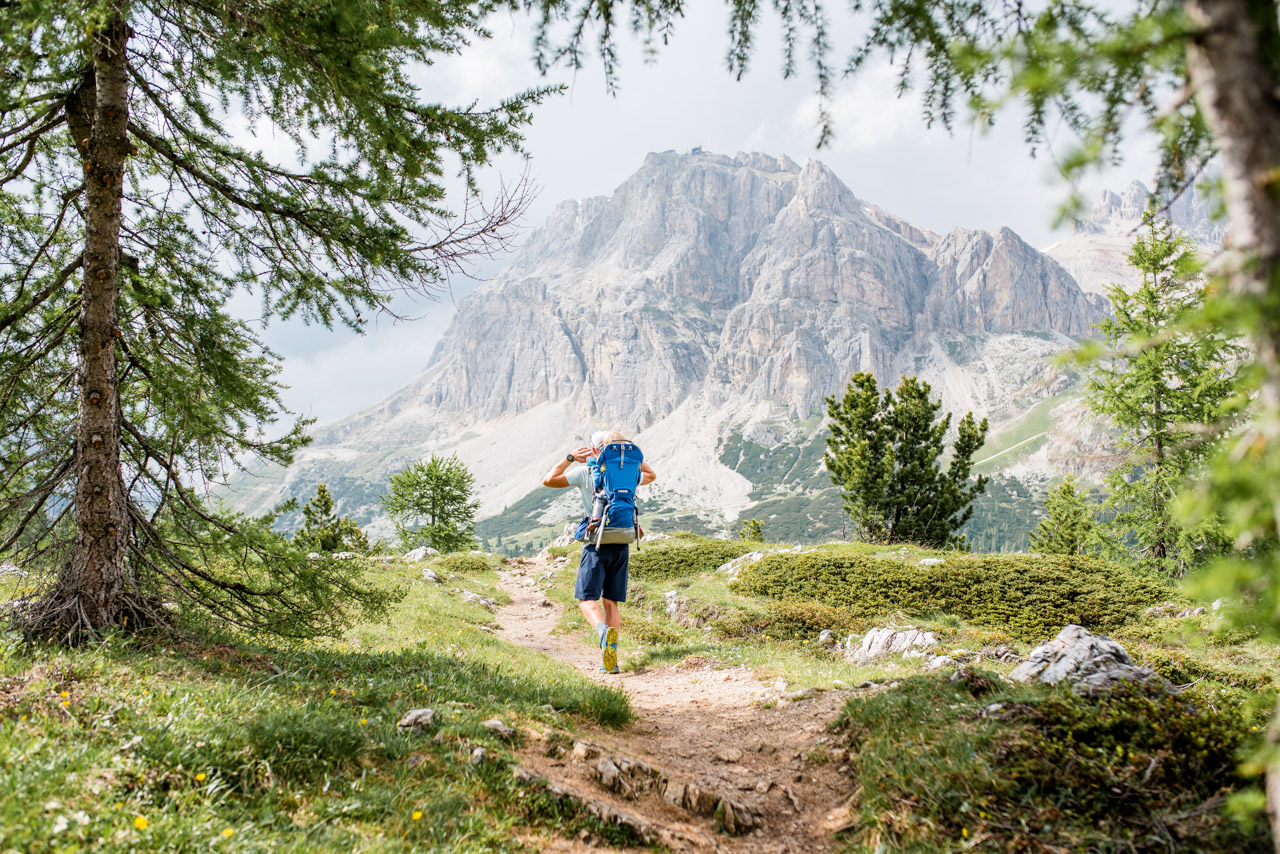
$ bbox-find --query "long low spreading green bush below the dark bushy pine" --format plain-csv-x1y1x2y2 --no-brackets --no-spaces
739,552,1170,640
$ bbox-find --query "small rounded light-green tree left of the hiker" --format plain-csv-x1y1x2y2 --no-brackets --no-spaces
383,455,480,554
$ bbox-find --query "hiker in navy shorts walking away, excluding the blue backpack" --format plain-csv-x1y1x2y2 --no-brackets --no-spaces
543,430,658,673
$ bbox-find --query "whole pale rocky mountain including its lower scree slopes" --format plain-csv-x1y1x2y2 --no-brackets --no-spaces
232,152,1121,527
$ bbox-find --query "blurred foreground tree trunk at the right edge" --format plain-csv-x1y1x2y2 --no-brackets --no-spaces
1187,0,1280,853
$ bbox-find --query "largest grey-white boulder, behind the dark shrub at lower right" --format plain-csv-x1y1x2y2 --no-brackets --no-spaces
1009,624,1164,694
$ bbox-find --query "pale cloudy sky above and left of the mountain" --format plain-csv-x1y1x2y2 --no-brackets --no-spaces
237,3,1155,424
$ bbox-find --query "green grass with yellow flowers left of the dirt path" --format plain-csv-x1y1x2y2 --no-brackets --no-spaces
0,565,634,851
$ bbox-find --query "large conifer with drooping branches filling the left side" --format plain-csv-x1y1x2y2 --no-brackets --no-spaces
0,0,545,639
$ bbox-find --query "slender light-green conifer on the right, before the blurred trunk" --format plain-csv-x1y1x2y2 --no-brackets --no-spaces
1088,201,1242,575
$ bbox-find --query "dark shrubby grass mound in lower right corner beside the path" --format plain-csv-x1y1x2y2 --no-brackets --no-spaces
840,673,1271,853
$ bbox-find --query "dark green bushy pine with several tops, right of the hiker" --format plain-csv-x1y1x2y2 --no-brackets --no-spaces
823,373,987,548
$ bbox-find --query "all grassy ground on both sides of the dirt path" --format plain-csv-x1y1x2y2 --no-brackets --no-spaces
0,538,1277,851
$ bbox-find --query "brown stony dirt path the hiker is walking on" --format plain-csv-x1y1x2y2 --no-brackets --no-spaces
498,561,850,854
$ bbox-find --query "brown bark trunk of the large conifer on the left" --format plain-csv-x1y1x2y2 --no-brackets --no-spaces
37,8,131,640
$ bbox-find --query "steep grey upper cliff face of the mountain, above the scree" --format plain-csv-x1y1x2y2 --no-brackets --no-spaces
384,154,1102,430
